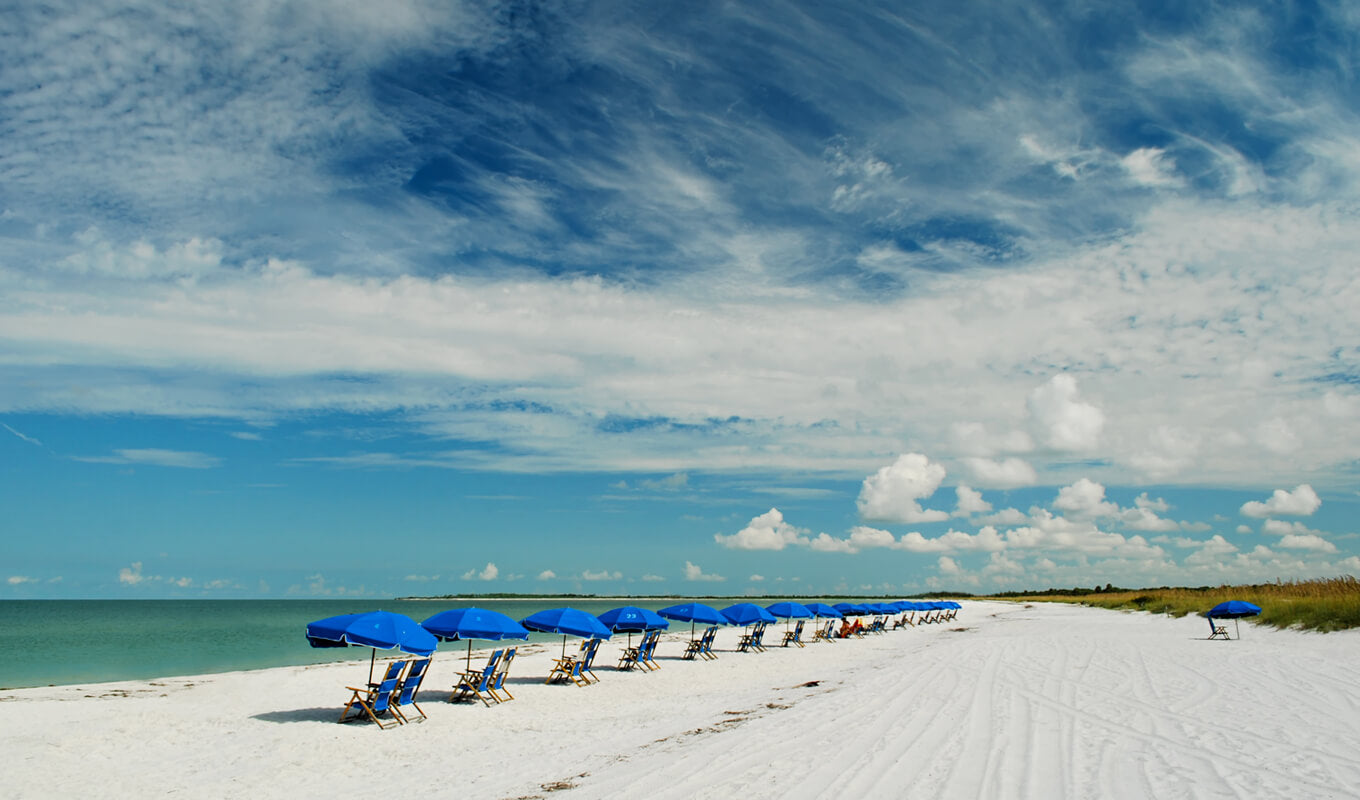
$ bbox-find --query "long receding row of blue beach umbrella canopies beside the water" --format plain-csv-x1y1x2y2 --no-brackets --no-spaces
306,600,959,680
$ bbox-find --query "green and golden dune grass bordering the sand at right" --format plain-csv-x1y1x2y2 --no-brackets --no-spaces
1000,576,1360,631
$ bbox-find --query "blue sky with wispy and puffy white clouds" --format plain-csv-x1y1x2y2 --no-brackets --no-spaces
0,0,1360,599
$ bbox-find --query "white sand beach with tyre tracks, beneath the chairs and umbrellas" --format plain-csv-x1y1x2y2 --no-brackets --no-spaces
0,603,1360,800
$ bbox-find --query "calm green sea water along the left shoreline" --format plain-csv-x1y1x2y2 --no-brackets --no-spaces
0,599,836,688
